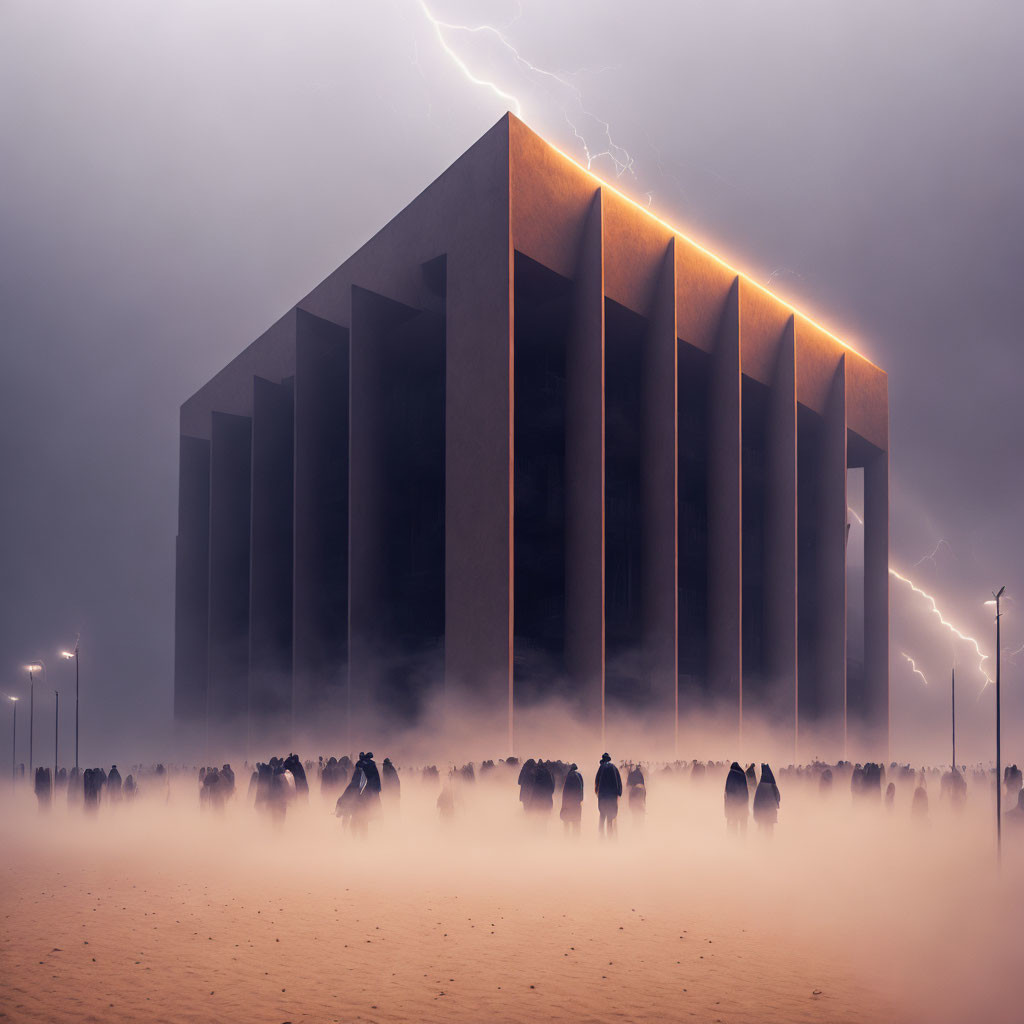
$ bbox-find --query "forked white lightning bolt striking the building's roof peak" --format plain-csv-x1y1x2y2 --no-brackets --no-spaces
417,0,636,177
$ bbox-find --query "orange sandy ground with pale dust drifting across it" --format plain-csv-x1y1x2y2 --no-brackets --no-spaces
0,770,1024,1024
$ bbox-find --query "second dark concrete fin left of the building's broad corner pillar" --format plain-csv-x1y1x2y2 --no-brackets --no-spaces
292,309,351,749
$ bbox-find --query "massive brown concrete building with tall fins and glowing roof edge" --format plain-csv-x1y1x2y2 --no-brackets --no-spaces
175,115,889,758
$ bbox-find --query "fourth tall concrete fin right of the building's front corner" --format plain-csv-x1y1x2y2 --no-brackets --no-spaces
764,316,798,746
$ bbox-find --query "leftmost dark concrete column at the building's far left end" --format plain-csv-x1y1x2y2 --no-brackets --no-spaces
174,434,210,723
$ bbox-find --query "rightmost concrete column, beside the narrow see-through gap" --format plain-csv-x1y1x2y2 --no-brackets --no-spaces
864,452,890,760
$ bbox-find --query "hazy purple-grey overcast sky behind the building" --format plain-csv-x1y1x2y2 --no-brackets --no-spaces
0,0,1024,762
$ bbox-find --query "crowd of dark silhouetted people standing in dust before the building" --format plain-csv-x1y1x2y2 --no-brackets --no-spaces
14,752,1024,838
